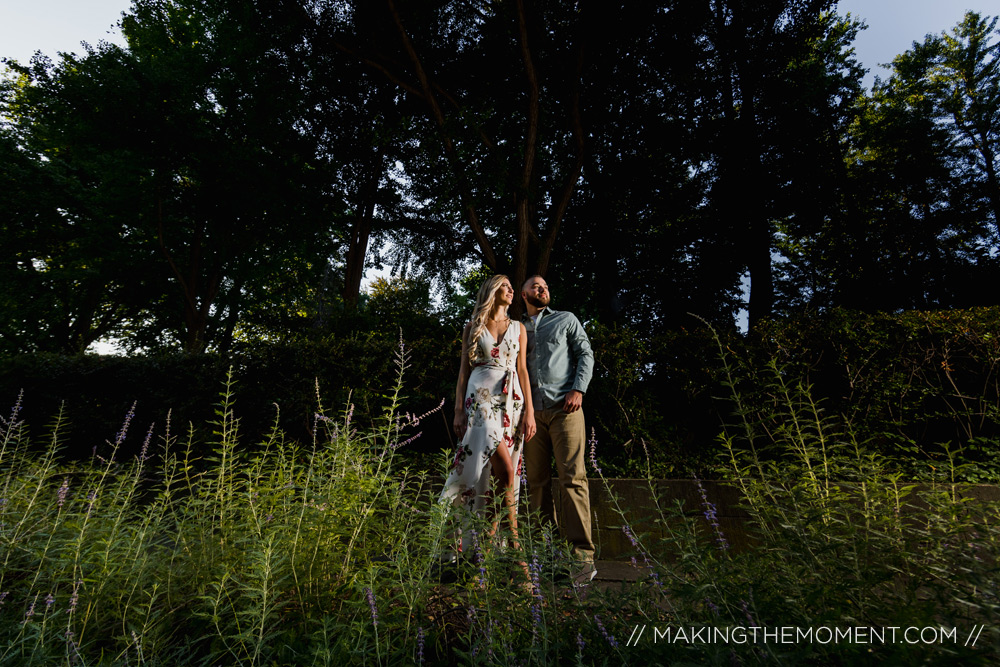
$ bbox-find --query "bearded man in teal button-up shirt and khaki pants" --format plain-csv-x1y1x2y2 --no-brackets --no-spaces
521,276,597,584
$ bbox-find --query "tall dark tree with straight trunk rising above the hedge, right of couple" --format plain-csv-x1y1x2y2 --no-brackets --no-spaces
705,0,857,328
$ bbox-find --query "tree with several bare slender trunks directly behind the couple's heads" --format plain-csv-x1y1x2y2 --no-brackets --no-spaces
328,0,590,302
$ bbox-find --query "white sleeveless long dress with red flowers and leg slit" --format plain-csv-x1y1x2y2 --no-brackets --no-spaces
441,320,524,536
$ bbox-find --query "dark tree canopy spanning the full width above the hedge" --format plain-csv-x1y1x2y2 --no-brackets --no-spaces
0,0,1000,354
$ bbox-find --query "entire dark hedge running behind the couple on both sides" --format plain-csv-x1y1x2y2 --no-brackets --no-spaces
0,308,1000,482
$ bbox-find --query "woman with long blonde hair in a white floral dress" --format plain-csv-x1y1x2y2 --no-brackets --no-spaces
441,275,535,549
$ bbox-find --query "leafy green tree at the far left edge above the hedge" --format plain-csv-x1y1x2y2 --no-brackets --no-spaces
0,52,164,352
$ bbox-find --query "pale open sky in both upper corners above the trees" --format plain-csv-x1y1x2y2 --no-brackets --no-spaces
0,0,1000,79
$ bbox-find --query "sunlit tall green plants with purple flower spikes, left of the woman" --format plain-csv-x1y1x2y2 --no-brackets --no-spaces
0,350,454,664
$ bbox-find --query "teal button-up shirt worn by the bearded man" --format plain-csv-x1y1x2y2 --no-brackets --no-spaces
522,308,594,410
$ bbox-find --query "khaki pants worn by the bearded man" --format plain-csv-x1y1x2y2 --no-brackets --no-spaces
524,408,594,562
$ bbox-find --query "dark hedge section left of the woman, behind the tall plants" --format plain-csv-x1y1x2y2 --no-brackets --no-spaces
0,327,459,458
